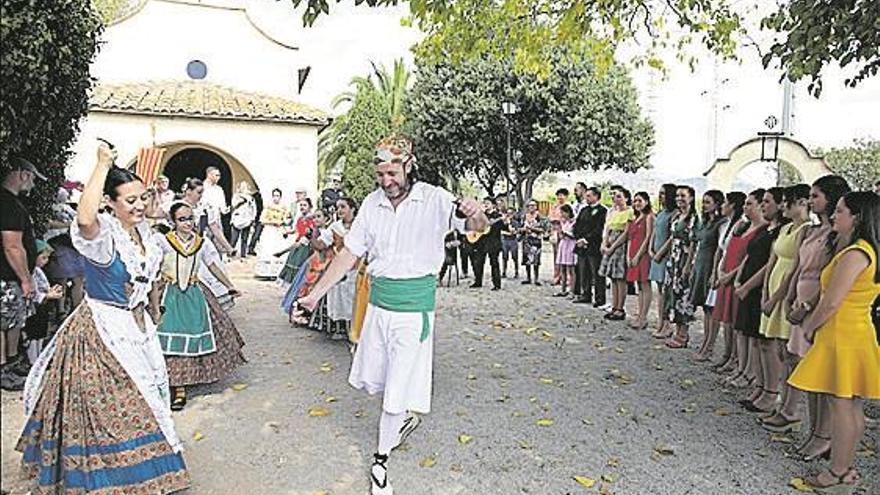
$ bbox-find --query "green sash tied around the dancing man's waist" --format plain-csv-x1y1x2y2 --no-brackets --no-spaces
370,275,437,342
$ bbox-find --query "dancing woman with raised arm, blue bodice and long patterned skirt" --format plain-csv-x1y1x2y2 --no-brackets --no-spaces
16,145,189,495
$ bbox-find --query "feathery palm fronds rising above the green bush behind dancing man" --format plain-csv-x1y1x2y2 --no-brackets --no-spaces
318,59,410,182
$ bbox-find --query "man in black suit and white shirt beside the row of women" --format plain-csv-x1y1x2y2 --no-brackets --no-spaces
574,187,608,308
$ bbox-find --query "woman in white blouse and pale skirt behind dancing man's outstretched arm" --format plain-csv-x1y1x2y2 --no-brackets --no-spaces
302,198,358,340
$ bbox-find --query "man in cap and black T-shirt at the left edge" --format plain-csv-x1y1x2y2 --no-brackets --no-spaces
0,158,46,390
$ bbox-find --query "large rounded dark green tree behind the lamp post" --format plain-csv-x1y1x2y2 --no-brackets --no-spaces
408,54,653,204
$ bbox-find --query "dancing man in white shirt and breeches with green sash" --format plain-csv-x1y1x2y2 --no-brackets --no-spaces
299,136,489,495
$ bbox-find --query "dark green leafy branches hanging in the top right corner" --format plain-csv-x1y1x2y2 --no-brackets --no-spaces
762,0,880,96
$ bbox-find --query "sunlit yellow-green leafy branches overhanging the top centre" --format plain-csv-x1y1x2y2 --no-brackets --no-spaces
290,0,743,77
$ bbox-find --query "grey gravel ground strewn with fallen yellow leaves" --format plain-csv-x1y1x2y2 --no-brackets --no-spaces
2,263,880,495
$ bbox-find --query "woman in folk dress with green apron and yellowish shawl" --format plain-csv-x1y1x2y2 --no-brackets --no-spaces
158,202,245,411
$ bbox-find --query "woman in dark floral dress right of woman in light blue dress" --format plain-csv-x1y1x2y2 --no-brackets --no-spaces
658,186,699,349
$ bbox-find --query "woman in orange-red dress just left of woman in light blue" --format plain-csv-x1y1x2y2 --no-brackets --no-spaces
626,191,654,330
